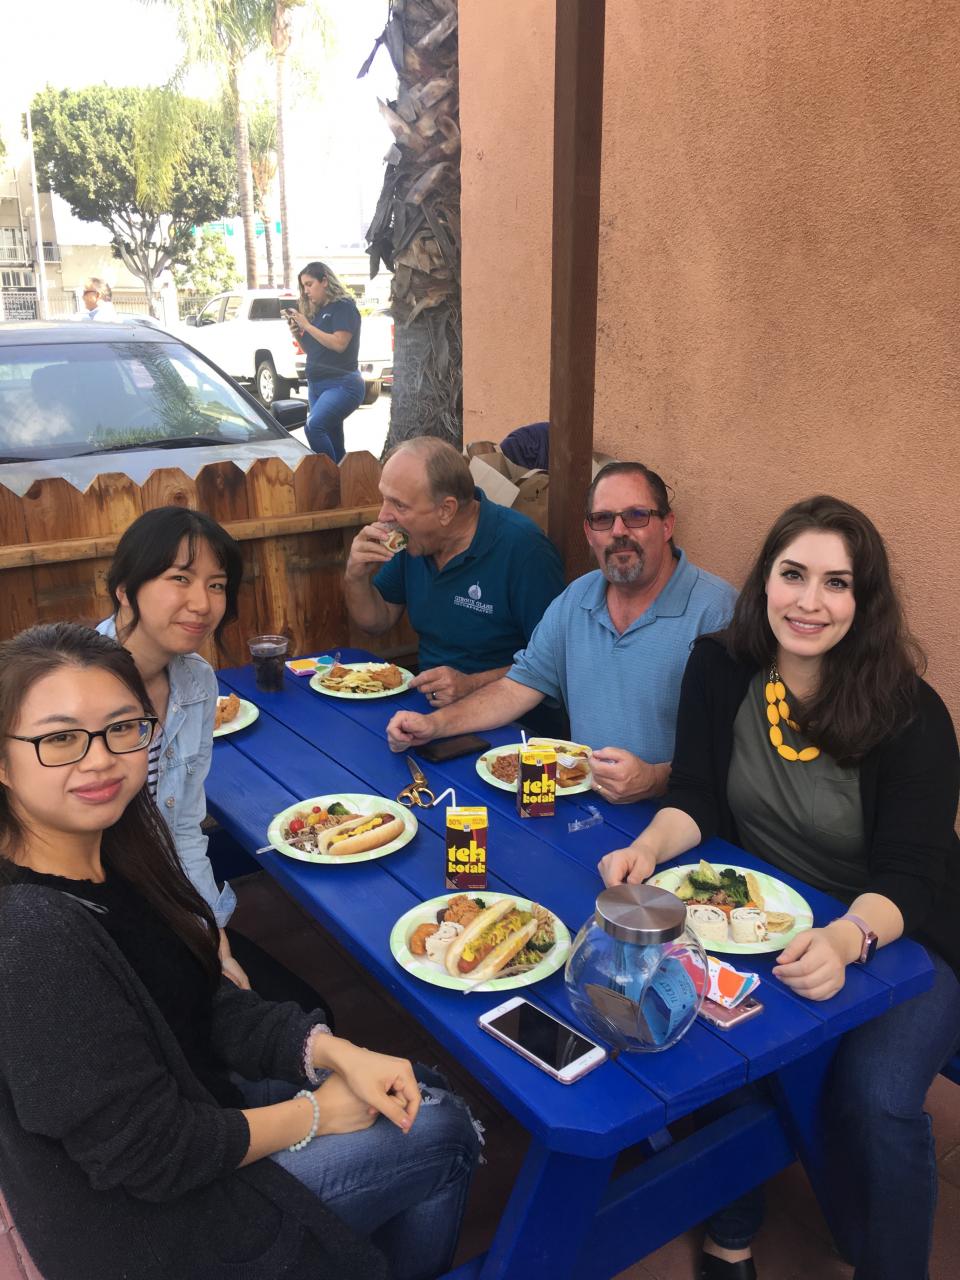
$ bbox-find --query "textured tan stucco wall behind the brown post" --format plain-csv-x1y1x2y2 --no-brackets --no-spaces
461,0,960,721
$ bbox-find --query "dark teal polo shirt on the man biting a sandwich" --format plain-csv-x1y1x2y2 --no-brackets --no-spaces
374,489,563,673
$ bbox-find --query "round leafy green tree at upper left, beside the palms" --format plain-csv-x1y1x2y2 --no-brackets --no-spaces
32,84,237,310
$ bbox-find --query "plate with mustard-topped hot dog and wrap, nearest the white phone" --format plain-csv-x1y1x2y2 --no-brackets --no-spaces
390,890,570,992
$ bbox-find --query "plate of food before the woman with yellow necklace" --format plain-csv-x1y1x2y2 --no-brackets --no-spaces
646,860,813,955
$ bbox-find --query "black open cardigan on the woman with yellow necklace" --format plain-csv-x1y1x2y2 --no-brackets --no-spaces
663,635,960,973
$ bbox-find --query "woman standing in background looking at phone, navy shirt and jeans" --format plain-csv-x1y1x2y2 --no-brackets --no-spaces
287,262,364,462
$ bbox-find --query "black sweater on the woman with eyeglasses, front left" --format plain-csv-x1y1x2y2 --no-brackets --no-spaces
0,884,387,1280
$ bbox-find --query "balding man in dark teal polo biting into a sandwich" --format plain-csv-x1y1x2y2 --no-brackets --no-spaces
344,436,563,707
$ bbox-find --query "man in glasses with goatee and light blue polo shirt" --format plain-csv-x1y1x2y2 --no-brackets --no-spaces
387,462,736,803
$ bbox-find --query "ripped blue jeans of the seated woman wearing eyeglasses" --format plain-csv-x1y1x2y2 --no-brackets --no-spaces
234,1066,480,1280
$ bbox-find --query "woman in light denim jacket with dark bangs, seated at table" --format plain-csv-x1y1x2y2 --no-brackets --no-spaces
97,507,329,1020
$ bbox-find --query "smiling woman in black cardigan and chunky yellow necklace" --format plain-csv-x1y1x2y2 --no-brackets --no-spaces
600,497,960,1280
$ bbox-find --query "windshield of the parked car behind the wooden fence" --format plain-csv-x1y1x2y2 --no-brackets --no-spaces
0,339,285,460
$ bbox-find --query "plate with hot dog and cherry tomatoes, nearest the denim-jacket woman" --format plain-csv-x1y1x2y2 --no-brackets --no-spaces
266,791,417,863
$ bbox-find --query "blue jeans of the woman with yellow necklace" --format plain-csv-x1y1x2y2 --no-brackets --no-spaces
707,952,960,1280
